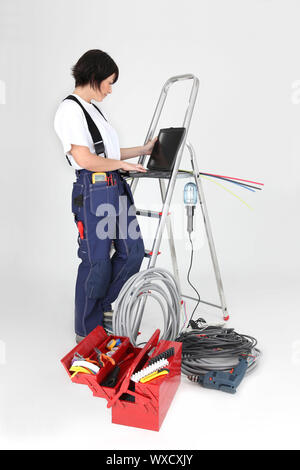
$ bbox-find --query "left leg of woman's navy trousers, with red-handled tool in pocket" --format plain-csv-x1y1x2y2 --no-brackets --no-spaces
73,174,118,336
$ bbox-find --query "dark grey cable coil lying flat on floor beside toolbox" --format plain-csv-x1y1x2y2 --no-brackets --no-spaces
176,322,260,376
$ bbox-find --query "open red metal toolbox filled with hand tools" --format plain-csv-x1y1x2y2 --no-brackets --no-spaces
61,326,182,431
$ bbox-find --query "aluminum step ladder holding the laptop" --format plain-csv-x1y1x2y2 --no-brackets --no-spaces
126,74,229,337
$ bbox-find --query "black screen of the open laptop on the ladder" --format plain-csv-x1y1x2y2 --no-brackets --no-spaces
147,127,185,171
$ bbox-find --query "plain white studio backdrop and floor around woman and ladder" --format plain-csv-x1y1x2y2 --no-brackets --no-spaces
0,0,300,449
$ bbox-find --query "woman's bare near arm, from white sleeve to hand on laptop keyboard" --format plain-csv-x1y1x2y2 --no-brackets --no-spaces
70,144,147,173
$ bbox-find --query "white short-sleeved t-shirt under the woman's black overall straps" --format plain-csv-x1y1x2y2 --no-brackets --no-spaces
54,93,121,170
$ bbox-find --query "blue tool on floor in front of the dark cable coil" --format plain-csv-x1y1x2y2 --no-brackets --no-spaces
197,358,248,393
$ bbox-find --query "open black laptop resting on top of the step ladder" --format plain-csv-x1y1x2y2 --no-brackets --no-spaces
122,127,185,178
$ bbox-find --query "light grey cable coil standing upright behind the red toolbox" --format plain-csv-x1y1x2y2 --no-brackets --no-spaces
113,267,181,346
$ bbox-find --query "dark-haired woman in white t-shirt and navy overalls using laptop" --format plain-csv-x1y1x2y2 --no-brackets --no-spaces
54,49,156,342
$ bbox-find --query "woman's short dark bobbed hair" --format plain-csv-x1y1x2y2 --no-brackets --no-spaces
72,49,119,88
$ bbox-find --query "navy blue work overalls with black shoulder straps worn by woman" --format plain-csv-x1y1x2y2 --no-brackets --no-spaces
68,95,145,336
